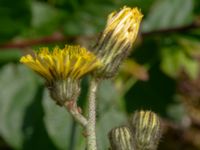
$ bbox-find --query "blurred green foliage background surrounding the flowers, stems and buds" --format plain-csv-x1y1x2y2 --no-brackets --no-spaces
0,0,200,150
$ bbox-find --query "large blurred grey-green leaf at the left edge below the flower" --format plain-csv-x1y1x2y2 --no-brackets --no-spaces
0,64,37,149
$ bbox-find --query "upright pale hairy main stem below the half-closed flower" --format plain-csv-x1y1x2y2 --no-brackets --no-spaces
86,79,99,150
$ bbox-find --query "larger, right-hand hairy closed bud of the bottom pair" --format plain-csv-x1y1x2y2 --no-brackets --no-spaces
130,111,161,150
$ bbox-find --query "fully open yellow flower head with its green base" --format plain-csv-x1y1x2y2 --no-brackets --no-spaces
20,46,101,105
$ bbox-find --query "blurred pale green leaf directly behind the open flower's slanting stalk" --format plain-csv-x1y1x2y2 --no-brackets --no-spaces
43,91,85,150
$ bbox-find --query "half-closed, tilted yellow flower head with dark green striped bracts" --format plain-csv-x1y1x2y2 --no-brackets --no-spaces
94,7,143,78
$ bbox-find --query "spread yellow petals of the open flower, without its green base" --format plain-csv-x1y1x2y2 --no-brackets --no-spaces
20,46,101,81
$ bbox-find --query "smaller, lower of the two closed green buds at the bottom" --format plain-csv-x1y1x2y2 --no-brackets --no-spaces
109,126,134,150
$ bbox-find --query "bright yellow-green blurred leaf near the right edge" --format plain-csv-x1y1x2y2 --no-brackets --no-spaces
161,47,199,79
